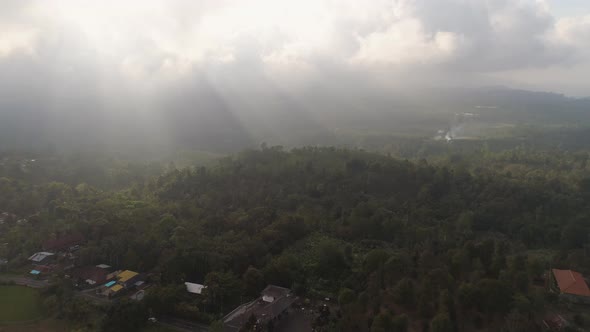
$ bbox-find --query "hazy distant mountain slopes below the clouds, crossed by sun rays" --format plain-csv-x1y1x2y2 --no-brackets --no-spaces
0,84,590,151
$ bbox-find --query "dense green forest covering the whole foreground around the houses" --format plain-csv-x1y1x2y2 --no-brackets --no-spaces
0,134,590,332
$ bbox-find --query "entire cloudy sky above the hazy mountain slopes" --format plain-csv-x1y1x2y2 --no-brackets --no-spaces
0,0,590,150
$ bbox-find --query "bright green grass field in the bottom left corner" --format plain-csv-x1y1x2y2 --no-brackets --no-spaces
0,286,43,325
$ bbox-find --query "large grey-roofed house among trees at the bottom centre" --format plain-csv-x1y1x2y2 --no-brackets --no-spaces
223,285,297,332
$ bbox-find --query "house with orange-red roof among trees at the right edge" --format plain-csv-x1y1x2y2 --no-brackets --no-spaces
551,269,590,304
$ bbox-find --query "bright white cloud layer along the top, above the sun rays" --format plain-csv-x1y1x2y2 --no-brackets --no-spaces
0,0,590,93
